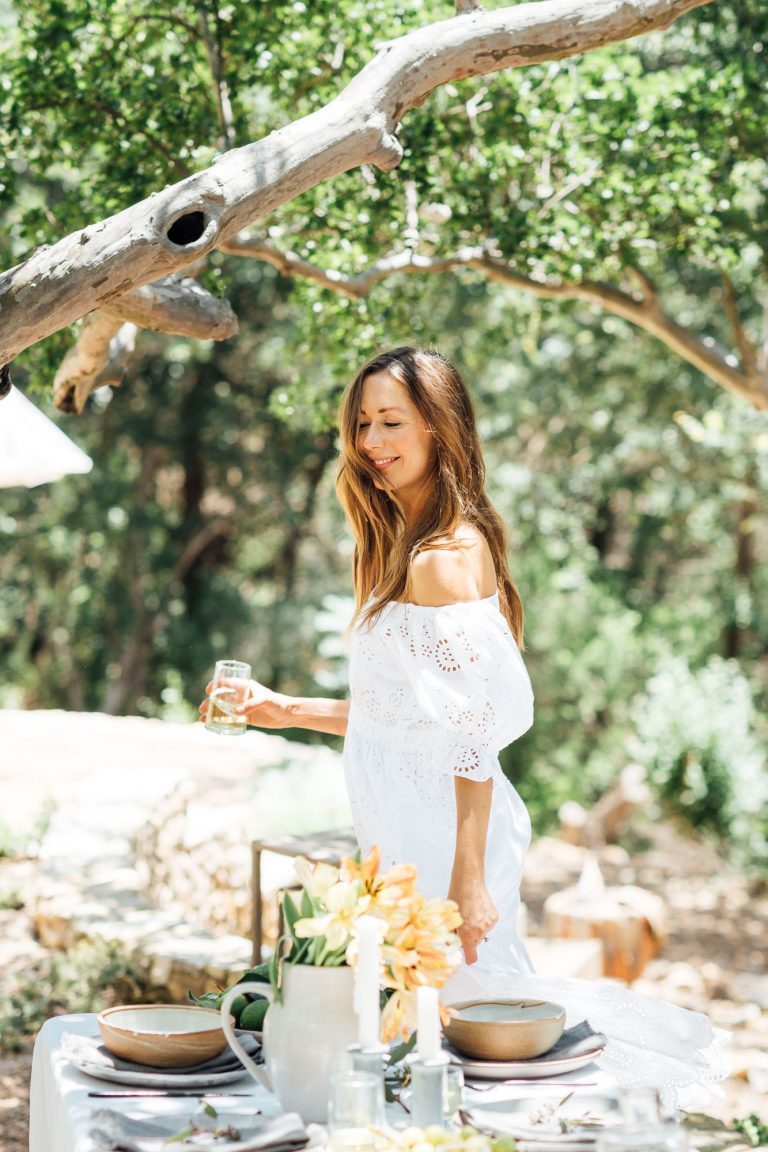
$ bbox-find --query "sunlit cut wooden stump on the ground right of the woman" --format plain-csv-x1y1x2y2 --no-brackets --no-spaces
543,885,666,983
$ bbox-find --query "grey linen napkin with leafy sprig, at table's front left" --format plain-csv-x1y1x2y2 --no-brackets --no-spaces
89,1108,310,1152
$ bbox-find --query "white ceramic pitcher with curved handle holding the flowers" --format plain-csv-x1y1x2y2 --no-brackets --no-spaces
221,964,357,1123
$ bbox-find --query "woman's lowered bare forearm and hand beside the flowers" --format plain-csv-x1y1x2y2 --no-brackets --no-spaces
448,776,499,964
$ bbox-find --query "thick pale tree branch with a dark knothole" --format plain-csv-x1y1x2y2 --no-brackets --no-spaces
0,0,709,366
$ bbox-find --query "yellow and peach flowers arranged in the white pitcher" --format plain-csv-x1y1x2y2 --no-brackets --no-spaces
273,847,462,1040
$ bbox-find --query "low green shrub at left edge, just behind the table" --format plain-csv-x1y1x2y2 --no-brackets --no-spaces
0,941,147,1052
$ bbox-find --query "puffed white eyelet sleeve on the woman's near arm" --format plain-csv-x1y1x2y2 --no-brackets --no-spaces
393,598,533,781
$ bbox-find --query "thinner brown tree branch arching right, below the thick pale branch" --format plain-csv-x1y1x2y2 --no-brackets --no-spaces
222,238,768,410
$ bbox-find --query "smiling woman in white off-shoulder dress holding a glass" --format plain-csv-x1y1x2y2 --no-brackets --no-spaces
203,348,716,1097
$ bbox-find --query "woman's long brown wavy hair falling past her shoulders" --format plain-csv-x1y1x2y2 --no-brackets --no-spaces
336,348,523,647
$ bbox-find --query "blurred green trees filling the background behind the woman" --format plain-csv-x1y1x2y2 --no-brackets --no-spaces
0,0,768,859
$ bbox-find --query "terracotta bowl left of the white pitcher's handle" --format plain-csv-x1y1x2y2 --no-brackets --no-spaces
98,1005,227,1068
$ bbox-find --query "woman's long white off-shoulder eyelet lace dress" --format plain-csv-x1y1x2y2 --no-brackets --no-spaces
344,596,727,1107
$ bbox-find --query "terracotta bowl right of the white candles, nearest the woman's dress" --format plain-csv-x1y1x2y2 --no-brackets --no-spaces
444,1000,565,1060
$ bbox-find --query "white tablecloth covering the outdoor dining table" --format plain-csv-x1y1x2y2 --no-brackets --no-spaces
29,1013,617,1152
